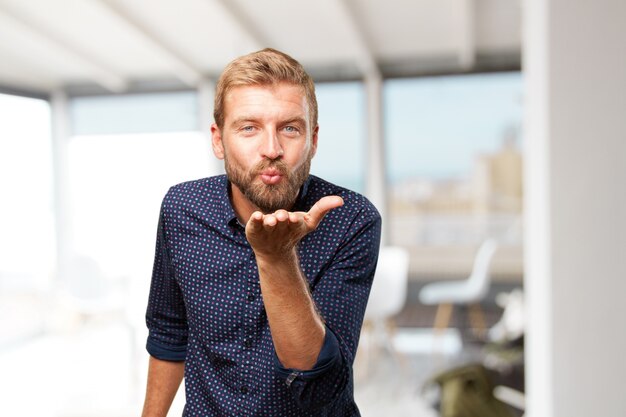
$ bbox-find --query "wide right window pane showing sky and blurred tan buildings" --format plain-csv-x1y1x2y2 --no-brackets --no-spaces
384,72,523,279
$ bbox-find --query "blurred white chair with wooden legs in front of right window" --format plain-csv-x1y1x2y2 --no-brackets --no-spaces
419,239,498,332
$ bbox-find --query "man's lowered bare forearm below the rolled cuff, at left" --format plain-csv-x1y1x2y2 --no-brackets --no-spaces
142,356,185,417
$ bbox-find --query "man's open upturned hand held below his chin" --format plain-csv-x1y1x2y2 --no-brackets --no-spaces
246,196,343,259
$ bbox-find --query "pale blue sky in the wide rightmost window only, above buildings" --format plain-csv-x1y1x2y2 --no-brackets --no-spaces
384,72,522,181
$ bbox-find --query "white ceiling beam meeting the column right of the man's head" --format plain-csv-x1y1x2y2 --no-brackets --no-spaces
330,0,381,78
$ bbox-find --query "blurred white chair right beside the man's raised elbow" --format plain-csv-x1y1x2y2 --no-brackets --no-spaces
363,246,409,372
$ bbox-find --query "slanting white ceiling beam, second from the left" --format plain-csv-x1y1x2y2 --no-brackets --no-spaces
93,0,203,87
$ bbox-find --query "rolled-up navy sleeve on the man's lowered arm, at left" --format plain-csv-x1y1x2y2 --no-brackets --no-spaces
146,196,188,361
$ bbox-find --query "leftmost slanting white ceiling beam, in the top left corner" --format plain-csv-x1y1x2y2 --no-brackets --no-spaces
0,3,127,92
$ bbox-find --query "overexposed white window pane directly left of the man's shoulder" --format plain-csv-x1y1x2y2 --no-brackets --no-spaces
68,132,213,283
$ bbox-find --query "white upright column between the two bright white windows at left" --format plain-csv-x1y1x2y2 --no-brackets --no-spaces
50,90,73,280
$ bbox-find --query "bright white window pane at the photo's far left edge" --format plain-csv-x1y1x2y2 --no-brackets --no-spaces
0,94,55,289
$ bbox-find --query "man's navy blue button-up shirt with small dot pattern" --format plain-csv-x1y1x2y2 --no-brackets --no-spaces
146,175,381,417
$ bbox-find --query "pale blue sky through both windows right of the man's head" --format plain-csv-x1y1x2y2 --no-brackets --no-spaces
312,72,523,190
